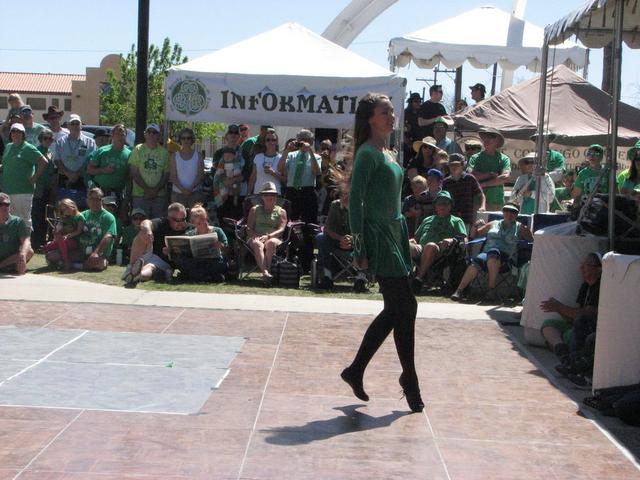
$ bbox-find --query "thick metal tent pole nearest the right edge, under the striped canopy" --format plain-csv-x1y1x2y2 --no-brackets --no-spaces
608,0,624,251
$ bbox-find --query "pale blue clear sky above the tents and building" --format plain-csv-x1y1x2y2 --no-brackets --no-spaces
0,0,640,106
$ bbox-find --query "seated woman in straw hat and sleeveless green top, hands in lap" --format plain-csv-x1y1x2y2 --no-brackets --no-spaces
247,182,287,285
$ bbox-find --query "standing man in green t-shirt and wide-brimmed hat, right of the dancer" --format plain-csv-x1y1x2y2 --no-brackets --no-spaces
467,127,511,211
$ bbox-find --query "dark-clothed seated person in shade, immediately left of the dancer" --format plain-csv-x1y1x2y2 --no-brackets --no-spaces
316,187,367,292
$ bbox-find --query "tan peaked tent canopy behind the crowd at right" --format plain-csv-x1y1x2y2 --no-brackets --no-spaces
453,65,640,145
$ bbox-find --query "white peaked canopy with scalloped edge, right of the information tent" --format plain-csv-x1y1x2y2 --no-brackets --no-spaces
389,5,585,72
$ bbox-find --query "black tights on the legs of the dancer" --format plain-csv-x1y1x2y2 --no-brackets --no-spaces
351,277,418,390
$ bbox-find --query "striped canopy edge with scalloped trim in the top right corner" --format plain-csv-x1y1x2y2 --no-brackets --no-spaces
544,0,640,48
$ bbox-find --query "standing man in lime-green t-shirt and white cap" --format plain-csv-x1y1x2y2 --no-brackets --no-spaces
129,123,169,218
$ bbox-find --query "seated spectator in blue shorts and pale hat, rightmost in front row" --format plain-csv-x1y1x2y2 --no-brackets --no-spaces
451,203,533,301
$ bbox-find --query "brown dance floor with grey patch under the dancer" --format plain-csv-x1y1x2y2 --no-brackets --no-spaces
0,301,640,480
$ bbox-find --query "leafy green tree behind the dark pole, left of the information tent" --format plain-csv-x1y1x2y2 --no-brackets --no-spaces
100,38,188,127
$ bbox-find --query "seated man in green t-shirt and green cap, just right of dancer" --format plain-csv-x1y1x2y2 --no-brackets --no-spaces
409,190,467,295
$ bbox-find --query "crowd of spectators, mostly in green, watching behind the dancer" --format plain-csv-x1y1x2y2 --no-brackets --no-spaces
0,89,640,308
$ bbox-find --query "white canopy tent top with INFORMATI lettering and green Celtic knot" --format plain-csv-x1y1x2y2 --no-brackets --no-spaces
165,23,406,128
